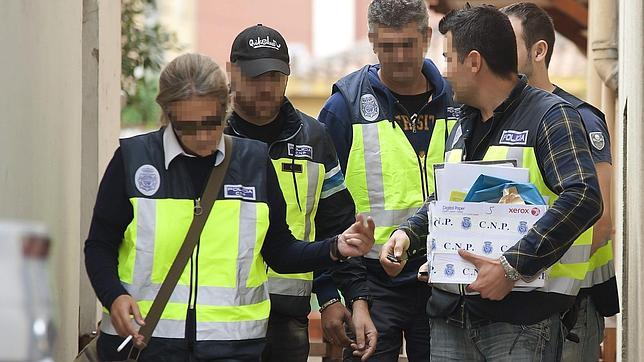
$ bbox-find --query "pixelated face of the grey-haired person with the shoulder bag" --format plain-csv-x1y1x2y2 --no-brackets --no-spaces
168,96,226,156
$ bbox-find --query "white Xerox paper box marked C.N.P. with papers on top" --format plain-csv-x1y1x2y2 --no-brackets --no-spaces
427,164,547,290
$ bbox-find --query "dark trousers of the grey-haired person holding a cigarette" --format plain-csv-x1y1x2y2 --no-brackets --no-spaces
96,333,266,362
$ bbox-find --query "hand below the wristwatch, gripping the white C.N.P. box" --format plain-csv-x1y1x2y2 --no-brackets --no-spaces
458,249,514,300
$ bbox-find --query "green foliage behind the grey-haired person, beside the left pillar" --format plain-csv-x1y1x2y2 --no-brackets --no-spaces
121,0,180,126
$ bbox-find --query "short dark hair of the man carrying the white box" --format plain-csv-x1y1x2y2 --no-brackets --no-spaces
438,5,518,77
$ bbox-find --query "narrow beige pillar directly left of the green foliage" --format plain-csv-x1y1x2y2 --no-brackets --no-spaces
78,0,121,335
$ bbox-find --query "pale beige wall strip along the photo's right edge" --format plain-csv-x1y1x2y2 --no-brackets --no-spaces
615,0,644,361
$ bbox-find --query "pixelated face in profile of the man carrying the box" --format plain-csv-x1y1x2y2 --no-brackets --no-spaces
443,31,476,104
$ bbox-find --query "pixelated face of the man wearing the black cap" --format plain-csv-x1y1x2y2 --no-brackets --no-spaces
230,64,288,123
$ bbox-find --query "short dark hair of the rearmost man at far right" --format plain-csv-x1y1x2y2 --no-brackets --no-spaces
501,2,555,67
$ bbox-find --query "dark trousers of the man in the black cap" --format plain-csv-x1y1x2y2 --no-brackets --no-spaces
262,310,309,362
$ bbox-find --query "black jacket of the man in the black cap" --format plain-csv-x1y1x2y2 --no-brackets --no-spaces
226,99,367,316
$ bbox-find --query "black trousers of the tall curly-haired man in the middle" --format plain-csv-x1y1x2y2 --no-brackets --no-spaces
344,279,431,362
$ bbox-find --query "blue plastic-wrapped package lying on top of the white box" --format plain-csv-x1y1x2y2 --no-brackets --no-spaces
464,175,546,205
